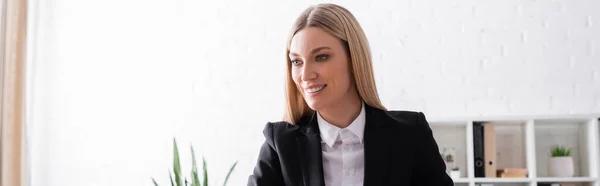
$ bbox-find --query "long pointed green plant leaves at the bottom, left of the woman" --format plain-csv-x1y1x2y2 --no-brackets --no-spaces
152,139,237,186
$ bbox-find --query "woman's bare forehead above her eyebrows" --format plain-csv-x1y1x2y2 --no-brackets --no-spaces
290,27,342,55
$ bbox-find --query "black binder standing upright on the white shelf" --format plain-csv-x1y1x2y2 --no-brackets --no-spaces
473,122,485,177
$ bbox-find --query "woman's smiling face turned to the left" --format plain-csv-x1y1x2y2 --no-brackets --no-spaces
289,27,356,110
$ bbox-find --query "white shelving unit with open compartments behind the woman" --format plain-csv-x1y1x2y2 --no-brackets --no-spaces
428,113,600,186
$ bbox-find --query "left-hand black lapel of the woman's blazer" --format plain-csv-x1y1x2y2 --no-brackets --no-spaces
296,113,325,186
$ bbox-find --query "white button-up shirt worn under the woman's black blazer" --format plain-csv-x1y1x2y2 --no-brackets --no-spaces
317,104,366,186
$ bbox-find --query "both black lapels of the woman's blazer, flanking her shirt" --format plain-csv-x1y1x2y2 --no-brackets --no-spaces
296,103,393,186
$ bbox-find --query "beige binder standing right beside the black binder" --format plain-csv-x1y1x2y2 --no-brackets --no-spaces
483,123,496,178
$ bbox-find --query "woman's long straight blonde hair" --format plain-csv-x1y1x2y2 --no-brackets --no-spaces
283,4,386,124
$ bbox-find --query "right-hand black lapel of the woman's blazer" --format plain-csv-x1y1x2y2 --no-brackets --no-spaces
364,104,390,185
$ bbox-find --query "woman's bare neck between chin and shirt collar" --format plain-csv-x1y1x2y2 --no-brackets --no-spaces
319,91,362,128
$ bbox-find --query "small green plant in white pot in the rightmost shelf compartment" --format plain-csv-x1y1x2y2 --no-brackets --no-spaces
548,145,573,177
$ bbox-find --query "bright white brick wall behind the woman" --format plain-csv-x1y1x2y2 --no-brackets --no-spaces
27,0,600,186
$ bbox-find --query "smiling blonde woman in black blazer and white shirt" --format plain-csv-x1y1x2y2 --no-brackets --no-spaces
248,4,453,186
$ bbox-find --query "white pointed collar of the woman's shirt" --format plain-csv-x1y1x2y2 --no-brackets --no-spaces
317,103,366,148
